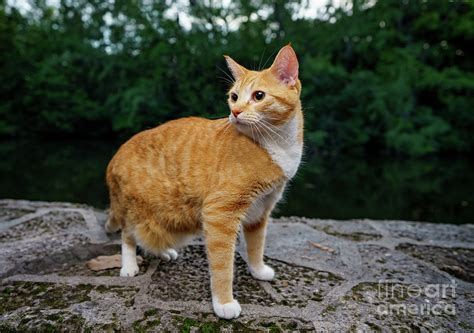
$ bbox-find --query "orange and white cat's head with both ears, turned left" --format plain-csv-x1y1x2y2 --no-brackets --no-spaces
225,45,301,132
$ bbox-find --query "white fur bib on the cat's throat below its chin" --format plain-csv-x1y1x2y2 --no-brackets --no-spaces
260,116,303,179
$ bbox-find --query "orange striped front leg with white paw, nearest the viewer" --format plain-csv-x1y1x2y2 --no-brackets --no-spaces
203,204,241,319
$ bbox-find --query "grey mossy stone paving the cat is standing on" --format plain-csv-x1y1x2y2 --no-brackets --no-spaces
0,200,474,332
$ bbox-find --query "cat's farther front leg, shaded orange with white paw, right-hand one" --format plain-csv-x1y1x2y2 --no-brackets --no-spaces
244,215,275,281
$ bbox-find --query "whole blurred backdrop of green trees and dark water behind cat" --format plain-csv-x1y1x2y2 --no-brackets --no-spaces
0,0,474,223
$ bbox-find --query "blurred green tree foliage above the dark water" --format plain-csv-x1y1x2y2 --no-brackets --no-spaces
0,0,474,155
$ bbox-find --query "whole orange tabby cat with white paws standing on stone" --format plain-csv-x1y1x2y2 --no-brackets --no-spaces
106,45,303,319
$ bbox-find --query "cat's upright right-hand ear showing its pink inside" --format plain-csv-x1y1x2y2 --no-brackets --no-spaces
270,44,299,86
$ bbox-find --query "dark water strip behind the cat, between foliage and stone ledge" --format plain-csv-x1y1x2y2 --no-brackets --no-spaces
0,137,474,224
